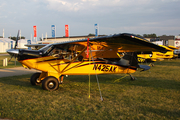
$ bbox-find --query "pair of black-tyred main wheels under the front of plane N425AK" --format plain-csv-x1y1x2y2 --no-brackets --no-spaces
30,72,64,91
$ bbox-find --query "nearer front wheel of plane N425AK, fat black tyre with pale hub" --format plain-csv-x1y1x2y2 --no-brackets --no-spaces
42,76,59,91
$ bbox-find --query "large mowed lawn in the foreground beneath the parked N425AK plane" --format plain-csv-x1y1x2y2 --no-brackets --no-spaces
0,60,180,120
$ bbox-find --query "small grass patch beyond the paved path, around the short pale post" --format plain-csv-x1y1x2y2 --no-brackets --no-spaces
0,55,22,69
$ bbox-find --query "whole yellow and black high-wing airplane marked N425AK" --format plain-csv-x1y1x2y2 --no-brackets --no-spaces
7,33,166,90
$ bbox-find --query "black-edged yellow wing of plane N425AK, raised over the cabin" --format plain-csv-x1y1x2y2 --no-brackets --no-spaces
50,33,167,52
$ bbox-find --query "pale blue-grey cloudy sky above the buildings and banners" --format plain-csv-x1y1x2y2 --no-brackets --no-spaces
0,0,180,39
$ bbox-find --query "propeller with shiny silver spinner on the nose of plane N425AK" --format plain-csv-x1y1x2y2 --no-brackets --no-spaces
7,30,19,62
